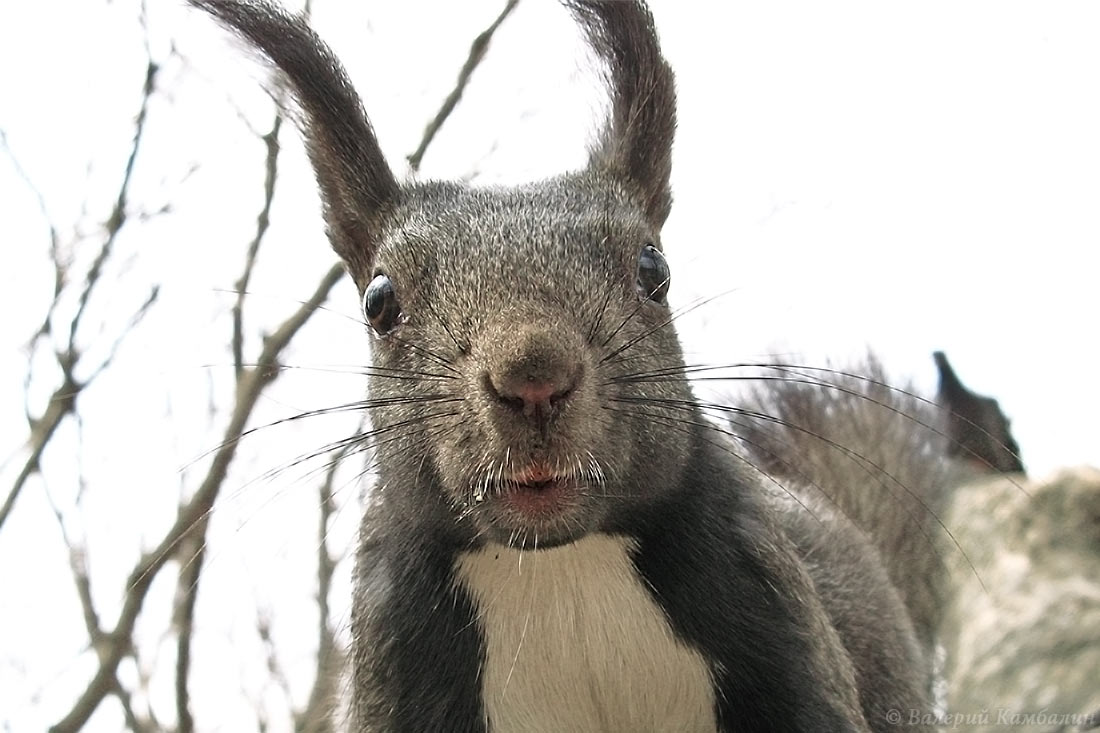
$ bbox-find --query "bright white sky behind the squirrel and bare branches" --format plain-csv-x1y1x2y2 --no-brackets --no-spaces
0,0,1100,730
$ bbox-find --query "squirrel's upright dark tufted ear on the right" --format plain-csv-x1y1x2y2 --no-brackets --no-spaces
567,0,677,227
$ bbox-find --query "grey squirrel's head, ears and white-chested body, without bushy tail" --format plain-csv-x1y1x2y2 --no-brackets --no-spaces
189,0,1007,733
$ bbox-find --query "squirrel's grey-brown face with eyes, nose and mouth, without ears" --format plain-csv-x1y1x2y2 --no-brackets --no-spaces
356,173,691,547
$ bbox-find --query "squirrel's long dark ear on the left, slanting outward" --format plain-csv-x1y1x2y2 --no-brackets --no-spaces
188,0,400,286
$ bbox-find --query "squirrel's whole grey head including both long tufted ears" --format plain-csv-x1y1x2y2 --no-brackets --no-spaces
190,0,686,547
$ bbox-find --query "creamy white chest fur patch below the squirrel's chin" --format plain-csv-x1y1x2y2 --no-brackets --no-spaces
457,535,716,733
